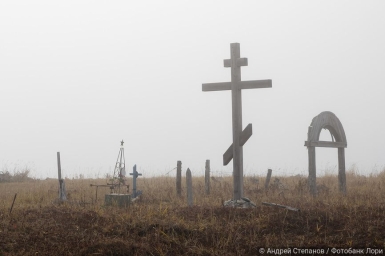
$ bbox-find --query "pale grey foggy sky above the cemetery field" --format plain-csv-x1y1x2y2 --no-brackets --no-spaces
0,0,385,178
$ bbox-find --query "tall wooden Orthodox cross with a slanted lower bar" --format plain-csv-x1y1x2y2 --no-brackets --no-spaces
202,43,272,200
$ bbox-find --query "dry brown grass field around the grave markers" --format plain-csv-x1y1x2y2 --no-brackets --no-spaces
0,171,385,255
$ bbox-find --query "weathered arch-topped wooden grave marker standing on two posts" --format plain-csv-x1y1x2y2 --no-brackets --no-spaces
305,111,348,196
